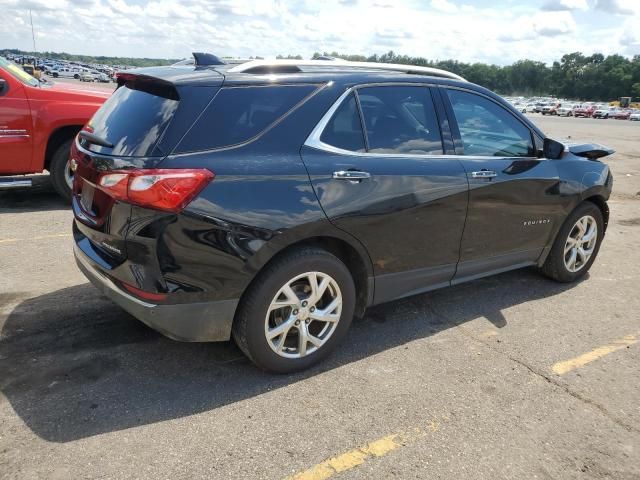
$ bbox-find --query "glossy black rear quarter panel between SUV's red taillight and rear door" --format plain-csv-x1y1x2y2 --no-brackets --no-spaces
127,85,370,302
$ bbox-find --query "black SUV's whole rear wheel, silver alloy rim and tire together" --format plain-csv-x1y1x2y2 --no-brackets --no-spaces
233,248,355,373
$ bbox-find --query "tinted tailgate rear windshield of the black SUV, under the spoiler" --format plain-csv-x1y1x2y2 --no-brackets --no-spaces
89,84,180,157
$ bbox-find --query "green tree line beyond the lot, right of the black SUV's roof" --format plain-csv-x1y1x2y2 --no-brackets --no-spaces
313,51,640,101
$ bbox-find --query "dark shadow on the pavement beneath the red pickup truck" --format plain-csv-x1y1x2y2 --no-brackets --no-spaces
0,175,71,213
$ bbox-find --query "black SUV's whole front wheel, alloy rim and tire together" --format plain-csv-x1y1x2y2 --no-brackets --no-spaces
541,201,604,282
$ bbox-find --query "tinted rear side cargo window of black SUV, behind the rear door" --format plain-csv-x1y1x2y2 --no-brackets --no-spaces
175,85,317,153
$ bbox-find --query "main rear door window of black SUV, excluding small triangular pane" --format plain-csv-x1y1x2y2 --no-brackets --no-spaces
358,86,443,155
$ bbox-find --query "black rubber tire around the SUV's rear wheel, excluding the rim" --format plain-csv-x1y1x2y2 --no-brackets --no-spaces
233,247,356,373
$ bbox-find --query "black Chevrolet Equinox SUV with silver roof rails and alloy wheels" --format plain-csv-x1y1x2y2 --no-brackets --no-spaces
71,55,612,372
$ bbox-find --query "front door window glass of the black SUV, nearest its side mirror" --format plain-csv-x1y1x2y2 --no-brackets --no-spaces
447,89,535,157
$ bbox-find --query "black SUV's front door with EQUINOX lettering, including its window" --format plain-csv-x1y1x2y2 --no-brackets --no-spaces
441,88,563,280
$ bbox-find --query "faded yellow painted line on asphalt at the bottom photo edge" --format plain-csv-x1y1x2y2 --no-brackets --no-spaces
286,420,440,480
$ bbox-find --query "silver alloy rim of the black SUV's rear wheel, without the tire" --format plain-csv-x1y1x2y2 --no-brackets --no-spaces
264,272,342,358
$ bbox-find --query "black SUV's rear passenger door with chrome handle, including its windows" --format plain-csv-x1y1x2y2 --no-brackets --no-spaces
302,84,468,303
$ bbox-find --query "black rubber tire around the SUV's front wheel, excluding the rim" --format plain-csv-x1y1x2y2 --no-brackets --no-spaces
540,201,604,283
